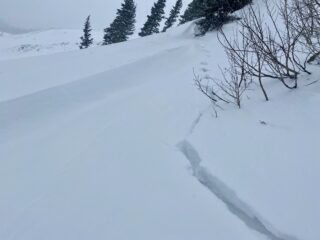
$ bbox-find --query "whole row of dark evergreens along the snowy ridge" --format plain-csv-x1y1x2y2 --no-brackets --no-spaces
80,0,252,49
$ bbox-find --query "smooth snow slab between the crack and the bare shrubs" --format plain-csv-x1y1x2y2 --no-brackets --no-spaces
186,75,320,239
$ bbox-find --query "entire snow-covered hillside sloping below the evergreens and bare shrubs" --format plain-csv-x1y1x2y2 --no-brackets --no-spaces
0,4,320,240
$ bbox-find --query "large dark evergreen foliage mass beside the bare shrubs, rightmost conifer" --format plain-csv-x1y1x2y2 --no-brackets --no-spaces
180,0,252,35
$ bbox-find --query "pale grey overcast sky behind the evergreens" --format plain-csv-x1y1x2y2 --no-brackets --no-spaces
0,0,191,29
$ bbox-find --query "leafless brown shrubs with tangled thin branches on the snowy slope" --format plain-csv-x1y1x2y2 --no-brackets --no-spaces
195,0,320,108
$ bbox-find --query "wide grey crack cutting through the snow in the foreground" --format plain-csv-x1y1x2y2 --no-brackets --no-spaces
177,140,298,240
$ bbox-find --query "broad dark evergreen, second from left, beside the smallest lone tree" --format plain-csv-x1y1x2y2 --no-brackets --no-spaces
103,0,136,45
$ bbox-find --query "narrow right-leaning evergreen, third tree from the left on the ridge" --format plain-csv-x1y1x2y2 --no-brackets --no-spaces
139,0,166,37
